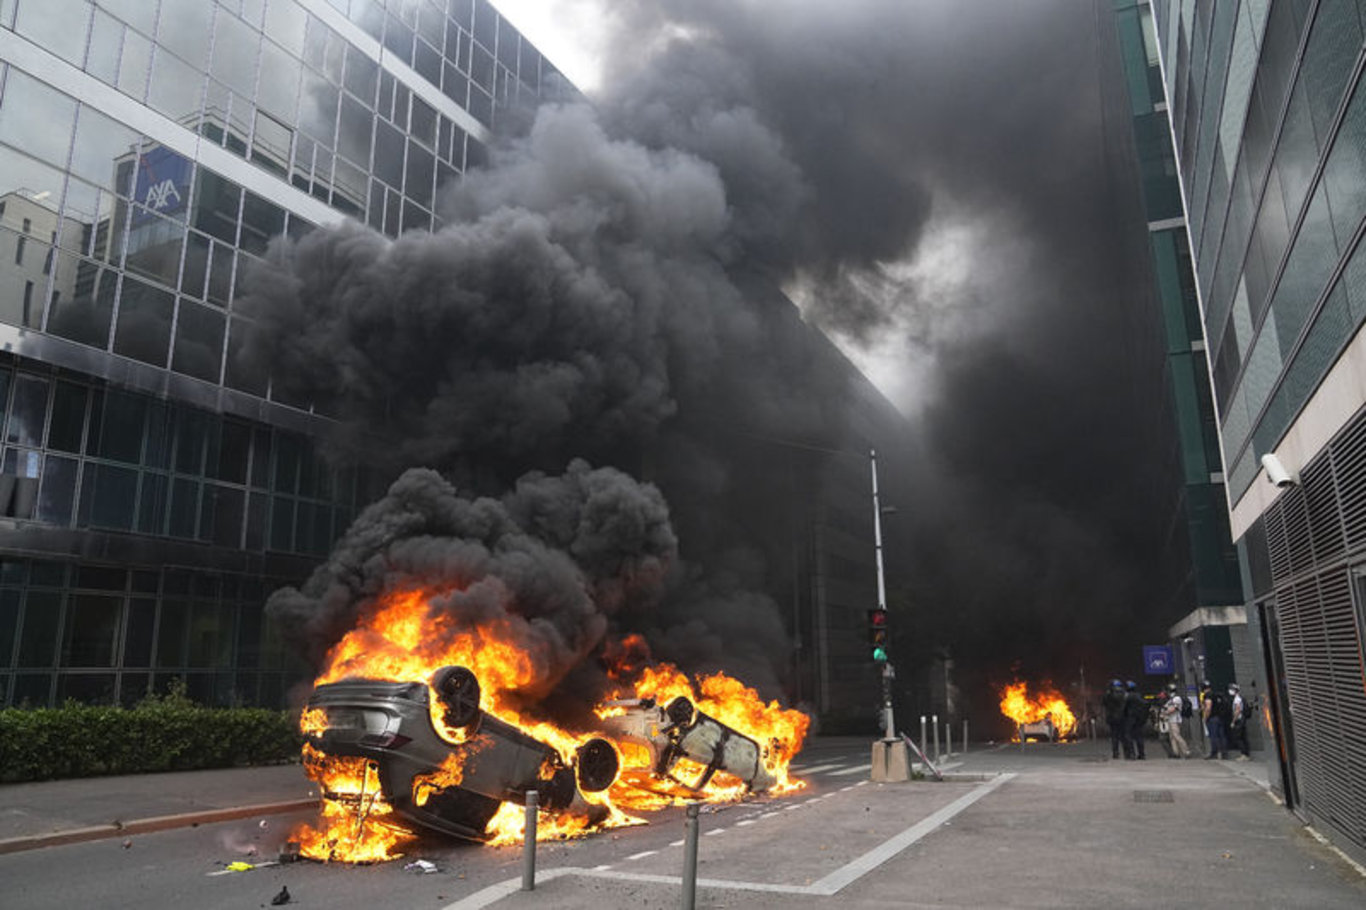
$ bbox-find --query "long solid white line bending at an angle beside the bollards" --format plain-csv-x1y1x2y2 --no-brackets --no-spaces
444,773,1015,910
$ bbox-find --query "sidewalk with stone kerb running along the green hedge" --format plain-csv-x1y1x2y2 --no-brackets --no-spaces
0,764,317,854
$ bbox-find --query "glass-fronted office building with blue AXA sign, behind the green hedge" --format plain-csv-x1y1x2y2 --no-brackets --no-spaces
0,0,563,706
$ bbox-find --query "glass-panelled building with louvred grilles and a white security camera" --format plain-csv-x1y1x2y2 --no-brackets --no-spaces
1145,0,1366,858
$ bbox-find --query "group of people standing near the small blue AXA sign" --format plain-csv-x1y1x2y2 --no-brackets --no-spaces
1101,679,1253,761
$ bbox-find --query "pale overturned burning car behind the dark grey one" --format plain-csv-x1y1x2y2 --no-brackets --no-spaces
602,695,777,792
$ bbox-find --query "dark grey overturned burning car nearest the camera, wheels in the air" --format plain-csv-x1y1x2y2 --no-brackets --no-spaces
301,658,620,842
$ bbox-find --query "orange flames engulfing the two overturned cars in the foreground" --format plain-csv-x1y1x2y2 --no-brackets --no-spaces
284,589,810,862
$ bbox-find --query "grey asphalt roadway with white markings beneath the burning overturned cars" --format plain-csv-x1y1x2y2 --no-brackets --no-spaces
0,741,1366,910
